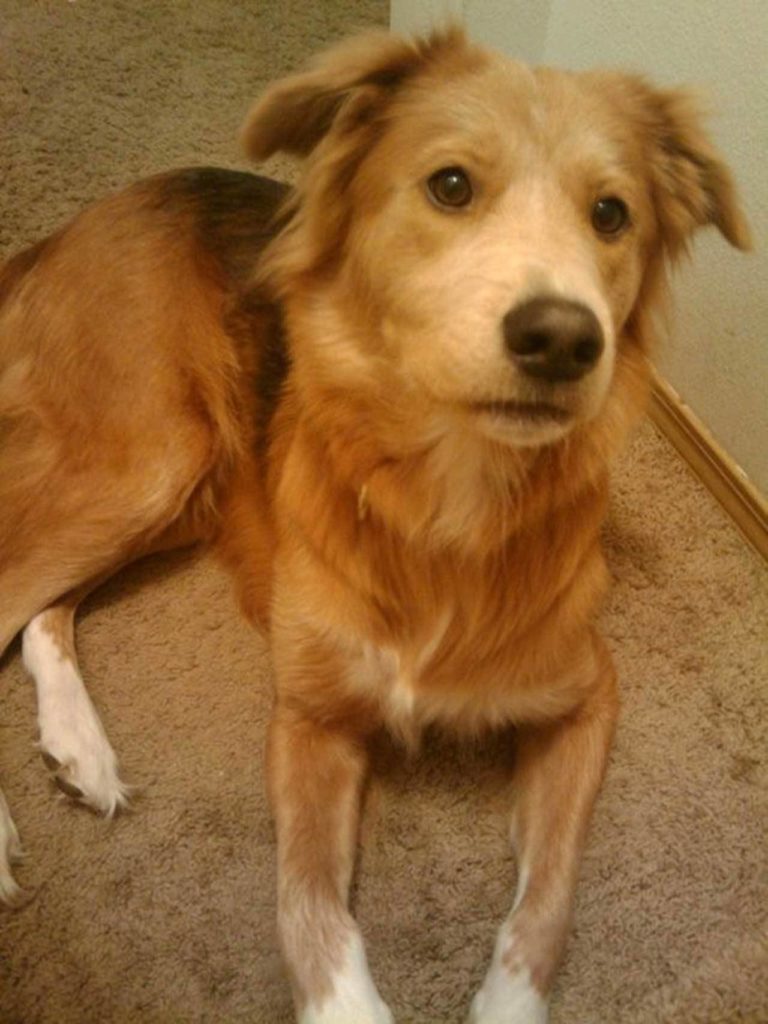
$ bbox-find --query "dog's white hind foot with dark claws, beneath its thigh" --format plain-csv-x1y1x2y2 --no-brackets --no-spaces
24,620,129,816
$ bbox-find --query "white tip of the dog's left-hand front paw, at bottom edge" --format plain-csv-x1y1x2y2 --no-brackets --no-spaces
299,934,394,1024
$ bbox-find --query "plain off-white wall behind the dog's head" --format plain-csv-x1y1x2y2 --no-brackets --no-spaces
391,0,768,494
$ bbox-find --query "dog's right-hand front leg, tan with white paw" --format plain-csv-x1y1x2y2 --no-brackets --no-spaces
470,639,618,1024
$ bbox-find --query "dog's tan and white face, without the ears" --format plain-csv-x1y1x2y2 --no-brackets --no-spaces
349,61,654,444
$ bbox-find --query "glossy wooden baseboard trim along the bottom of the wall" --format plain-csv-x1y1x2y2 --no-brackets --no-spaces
648,374,768,560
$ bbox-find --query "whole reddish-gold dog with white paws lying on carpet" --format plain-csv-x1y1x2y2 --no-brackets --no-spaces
0,28,749,1024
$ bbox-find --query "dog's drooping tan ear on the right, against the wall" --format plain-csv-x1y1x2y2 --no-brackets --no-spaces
645,89,751,256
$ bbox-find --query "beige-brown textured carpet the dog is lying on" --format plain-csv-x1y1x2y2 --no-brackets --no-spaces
0,0,768,1024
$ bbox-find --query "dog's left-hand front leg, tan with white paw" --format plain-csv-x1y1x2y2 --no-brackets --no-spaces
267,703,392,1024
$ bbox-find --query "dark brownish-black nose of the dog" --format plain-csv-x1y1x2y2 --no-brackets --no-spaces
502,296,604,383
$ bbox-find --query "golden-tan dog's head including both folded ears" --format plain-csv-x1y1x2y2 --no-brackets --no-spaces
244,30,749,445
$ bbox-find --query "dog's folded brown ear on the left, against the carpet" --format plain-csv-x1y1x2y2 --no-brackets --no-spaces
241,28,466,161
